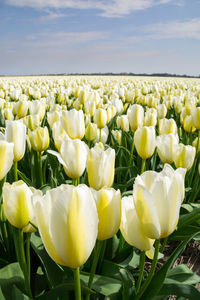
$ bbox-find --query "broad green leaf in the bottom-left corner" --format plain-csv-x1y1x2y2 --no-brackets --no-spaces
0,263,25,300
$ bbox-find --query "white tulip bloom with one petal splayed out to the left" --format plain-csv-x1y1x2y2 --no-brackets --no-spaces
48,139,88,178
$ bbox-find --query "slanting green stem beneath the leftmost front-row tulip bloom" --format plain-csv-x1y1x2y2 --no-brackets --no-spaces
13,228,33,299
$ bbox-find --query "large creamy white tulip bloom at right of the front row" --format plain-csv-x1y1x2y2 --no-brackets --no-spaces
133,164,186,239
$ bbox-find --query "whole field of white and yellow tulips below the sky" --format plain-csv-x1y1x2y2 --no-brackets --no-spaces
0,76,200,300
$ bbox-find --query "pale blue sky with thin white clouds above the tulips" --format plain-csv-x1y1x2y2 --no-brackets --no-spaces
0,0,200,76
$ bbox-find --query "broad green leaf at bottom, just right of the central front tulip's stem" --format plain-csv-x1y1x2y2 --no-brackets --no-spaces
80,272,121,296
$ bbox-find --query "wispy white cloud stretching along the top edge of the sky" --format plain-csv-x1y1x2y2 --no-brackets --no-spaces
4,0,180,18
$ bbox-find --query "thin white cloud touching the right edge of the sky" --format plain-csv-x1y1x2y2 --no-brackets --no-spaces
142,19,200,40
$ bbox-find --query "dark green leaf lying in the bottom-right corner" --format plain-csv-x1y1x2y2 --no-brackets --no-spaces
159,283,200,300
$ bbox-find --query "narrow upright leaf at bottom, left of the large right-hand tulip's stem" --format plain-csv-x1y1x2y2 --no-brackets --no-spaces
120,269,135,300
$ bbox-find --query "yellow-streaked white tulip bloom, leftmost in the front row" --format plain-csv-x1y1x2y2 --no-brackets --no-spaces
3,180,34,228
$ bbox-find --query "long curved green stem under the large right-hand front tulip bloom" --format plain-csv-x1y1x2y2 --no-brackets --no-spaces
134,240,160,300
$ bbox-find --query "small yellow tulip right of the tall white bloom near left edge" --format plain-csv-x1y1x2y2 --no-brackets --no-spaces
28,126,49,152
